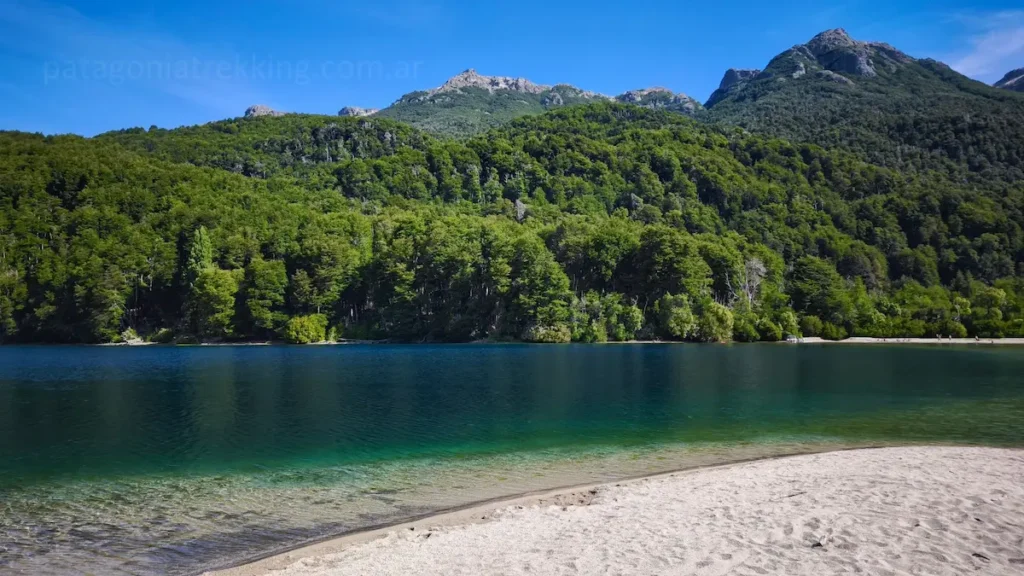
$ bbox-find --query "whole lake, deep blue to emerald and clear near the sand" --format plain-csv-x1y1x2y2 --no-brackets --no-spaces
0,345,1024,574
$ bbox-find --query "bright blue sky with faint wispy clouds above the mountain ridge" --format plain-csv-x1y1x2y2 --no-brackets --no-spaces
0,0,1024,135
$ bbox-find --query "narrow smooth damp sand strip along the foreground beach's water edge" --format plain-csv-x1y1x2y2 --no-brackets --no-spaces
197,443,888,576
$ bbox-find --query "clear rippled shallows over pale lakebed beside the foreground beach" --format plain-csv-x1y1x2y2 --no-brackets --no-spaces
0,442,864,575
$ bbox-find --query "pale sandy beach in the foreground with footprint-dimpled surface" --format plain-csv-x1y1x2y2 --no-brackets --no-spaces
209,447,1024,576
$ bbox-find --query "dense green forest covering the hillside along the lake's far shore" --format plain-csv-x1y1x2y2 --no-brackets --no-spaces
0,102,1024,342
